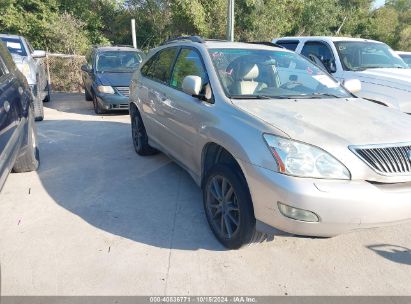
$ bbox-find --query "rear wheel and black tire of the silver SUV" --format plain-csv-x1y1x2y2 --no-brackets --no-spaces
130,110,158,156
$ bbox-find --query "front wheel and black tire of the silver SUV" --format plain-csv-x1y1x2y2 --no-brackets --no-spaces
203,164,266,249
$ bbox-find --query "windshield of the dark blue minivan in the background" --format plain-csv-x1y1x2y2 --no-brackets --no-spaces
96,51,142,73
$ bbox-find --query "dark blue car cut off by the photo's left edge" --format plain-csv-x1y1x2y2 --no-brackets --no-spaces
0,42,40,190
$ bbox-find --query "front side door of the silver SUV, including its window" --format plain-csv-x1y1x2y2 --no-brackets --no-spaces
156,47,210,172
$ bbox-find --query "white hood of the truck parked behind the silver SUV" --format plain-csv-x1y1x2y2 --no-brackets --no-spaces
352,68,411,92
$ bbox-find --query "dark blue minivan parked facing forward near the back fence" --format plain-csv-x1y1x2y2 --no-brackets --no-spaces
81,46,144,114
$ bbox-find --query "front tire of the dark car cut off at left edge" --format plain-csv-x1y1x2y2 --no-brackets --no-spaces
13,110,40,173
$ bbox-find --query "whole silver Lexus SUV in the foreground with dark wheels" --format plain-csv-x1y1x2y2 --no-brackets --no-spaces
130,37,411,248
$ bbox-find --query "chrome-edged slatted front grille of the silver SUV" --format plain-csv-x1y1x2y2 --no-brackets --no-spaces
350,143,411,175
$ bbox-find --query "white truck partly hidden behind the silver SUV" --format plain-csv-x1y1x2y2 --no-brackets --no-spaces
273,37,411,113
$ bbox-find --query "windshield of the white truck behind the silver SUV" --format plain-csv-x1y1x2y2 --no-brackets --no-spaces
334,41,407,71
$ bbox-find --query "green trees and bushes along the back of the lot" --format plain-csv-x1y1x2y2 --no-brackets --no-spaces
0,0,411,54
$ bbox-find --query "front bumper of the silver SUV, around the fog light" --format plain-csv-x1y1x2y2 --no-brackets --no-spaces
240,162,411,237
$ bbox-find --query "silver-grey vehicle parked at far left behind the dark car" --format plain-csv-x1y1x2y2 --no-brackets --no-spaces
0,34,50,121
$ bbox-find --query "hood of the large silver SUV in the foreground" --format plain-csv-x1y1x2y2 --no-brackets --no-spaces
234,98,411,147
